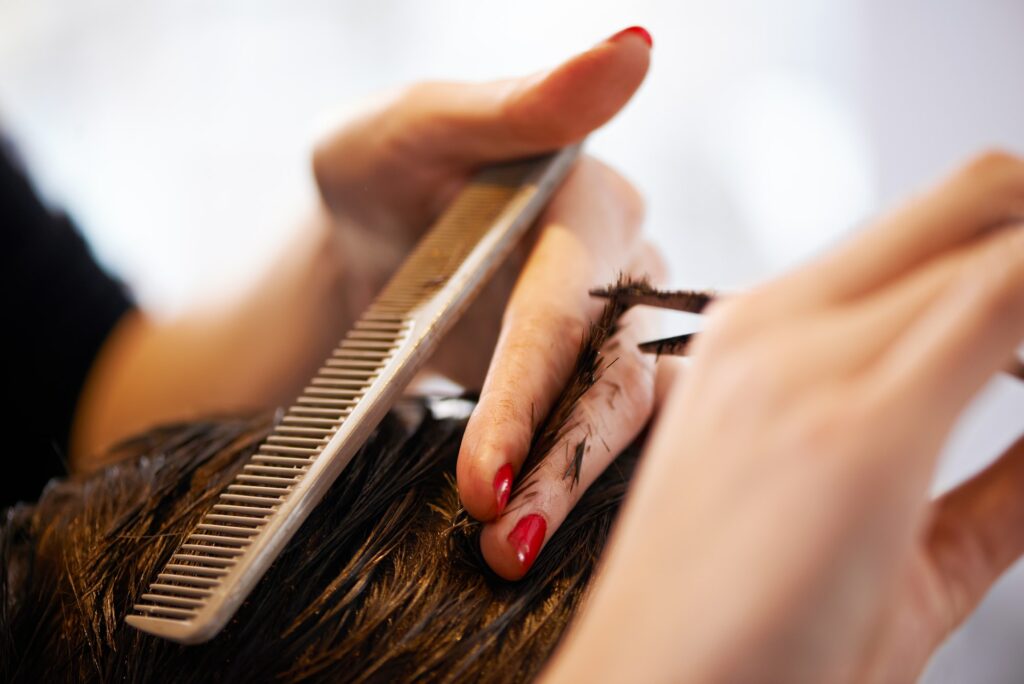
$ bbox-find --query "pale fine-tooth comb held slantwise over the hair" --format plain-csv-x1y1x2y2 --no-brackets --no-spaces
126,145,580,644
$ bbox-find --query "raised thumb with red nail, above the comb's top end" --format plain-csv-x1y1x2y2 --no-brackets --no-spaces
398,27,651,165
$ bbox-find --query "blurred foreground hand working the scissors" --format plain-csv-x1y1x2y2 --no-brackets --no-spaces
549,150,1024,683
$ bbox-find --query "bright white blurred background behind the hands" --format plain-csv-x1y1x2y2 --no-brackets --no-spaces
0,0,1024,684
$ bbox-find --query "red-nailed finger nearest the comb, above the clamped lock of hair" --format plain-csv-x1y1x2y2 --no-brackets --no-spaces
458,159,642,520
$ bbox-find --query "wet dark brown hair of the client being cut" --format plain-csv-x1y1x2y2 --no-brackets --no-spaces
0,278,637,682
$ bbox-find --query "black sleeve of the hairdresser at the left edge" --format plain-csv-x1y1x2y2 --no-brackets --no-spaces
0,141,132,508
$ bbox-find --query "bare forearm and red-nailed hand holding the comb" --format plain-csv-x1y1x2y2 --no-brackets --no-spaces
72,31,663,579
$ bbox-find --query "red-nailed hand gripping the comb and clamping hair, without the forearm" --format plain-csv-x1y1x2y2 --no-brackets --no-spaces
314,30,660,578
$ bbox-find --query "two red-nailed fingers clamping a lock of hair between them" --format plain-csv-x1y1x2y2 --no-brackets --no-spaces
468,159,664,580
